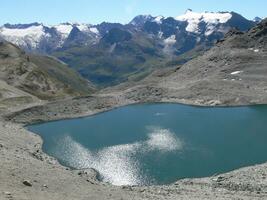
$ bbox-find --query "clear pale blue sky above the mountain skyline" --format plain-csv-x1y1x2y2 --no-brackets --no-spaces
0,0,267,24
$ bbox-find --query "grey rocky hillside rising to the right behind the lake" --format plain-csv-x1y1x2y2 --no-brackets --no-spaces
119,19,267,105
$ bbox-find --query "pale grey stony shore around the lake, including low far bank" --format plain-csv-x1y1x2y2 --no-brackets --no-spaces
0,91,267,200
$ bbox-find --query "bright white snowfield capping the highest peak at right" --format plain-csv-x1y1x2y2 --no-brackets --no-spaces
175,9,232,33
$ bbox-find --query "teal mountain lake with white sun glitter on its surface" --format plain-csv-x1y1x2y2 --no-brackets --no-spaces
28,104,267,185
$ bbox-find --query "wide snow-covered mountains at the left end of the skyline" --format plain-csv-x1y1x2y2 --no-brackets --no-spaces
0,22,99,50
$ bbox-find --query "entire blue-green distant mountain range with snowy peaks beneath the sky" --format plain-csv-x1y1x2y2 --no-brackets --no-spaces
0,9,260,87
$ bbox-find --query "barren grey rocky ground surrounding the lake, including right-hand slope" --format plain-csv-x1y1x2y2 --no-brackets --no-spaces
0,20,267,200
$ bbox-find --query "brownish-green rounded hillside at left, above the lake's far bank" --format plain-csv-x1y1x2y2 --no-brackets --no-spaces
0,41,94,112
